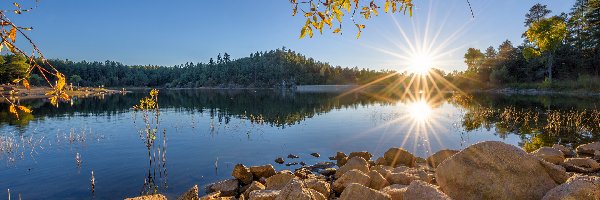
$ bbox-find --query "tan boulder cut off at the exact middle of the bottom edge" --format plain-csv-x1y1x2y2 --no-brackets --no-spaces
275,179,326,200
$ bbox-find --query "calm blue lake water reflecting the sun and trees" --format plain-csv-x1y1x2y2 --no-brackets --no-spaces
0,90,600,199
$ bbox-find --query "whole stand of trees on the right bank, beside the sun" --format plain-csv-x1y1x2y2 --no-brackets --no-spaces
448,0,600,89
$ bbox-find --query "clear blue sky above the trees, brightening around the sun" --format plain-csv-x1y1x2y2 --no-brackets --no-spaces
5,0,574,71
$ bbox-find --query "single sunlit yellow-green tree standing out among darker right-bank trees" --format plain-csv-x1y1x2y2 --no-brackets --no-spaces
525,16,567,81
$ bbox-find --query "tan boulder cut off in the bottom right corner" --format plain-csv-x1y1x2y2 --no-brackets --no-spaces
543,175,600,200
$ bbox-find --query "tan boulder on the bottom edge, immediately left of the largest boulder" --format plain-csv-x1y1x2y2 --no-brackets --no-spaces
402,181,452,200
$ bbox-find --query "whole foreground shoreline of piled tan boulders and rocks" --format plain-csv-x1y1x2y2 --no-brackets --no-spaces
125,141,600,200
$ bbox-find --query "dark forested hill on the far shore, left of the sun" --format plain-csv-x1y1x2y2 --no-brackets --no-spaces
16,47,395,88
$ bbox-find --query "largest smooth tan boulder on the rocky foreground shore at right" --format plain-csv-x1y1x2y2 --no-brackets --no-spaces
435,141,567,200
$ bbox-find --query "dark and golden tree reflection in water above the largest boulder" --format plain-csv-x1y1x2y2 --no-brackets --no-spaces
450,95,600,151
